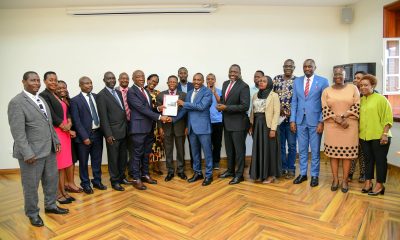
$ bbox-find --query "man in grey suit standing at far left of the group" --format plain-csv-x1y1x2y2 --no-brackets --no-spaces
8,71,68,227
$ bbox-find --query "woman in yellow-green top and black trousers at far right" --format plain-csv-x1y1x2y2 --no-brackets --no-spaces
359,75,393,196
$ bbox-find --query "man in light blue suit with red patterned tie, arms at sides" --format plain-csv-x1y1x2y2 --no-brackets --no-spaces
290,59,329,187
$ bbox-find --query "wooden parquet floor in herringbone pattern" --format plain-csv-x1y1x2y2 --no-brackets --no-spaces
0,158,400,240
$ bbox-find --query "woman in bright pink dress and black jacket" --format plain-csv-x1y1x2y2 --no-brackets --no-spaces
40,72,75,204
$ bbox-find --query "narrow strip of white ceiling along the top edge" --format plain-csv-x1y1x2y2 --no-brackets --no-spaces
0,0,362,9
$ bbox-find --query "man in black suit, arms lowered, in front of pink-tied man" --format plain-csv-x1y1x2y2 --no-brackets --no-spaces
97,72,131,191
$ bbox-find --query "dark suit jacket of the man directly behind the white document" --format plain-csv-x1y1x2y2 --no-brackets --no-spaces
157,90,186,136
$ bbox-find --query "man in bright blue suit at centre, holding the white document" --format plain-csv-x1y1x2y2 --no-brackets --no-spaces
175,73,213,186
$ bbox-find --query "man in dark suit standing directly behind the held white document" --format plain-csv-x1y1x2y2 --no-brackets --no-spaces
157,75,187,182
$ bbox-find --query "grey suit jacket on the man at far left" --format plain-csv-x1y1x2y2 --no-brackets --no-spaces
8,92,60,161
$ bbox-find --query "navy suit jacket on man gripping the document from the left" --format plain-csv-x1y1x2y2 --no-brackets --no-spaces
127,85,160,134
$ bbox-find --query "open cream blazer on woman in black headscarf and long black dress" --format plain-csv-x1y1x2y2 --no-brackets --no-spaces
250,92,281,131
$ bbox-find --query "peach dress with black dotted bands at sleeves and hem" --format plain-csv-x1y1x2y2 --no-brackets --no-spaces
321,84,360,159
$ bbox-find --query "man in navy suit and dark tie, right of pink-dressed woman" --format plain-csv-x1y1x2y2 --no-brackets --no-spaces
71,77,107,194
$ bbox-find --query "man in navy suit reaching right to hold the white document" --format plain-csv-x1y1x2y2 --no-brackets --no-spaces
128,70,170,190
